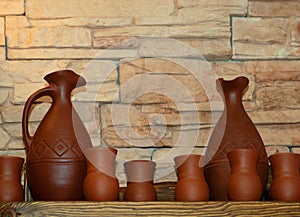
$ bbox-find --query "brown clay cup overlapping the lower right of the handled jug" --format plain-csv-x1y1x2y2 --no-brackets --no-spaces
83,147,119,201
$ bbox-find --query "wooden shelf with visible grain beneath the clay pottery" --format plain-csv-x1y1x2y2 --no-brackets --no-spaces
0,201,300,217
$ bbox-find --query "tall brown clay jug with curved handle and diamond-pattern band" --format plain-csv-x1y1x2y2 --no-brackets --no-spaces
22,70,92,200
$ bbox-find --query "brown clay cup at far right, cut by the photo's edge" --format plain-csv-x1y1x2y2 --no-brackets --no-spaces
269,153,300,202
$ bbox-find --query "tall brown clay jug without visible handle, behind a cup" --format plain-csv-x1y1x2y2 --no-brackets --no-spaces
205,77,269,201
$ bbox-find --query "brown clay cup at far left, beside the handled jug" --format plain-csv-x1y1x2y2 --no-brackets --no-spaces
0,156,24,202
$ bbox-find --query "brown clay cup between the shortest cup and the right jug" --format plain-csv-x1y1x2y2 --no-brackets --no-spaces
174,154,209,201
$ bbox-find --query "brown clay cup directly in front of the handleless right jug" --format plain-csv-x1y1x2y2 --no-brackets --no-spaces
227,149,263,201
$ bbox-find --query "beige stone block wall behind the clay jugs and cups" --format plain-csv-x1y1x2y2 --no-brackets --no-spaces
0,0,300,181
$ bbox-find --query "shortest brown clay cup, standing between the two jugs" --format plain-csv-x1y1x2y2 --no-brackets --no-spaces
124,160,157,201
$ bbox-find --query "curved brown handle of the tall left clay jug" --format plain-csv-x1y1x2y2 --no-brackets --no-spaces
22,86,55,150
